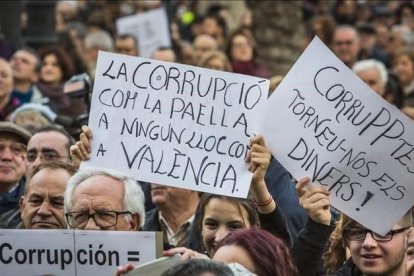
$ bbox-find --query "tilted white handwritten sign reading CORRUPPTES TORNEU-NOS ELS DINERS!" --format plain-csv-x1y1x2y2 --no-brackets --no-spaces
265,38,414,234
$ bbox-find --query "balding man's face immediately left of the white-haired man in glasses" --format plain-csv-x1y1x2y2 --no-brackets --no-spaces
20,169,70,229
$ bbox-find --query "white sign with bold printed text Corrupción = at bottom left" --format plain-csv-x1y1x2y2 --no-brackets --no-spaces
0,229,162,276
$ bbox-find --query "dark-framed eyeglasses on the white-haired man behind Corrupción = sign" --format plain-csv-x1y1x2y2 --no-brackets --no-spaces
65,211,131,229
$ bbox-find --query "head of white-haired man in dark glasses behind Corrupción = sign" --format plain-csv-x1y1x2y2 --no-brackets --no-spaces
65,168,145,231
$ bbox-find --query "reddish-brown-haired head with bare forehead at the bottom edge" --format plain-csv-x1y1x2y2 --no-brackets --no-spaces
213,227,298,276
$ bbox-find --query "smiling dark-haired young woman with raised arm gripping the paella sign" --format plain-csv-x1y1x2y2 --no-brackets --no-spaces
165,135,291,259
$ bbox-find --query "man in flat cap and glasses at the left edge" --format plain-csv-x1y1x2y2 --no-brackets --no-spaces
0,122,31,228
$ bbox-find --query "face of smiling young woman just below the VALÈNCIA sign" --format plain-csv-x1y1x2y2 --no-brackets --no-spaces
201,198,251,256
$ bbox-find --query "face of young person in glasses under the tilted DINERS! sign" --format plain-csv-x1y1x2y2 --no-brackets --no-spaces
348,224,407,275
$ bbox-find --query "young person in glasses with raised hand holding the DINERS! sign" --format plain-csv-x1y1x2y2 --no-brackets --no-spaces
293,177,412,276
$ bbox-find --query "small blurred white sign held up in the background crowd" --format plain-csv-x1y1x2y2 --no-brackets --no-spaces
116,8,171,57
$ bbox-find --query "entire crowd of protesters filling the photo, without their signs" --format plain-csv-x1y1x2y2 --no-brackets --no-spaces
0,0,414,276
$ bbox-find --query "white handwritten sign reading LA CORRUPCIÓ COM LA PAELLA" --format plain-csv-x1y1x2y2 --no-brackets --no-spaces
82,52,269,197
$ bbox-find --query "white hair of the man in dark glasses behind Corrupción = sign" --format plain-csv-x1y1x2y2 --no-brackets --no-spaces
64,168,145,227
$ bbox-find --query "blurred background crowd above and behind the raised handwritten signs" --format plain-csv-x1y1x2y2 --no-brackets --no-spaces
0,0,414,137
